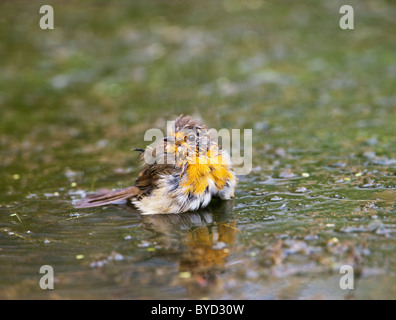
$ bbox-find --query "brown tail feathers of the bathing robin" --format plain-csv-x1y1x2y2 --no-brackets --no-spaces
74,186,140,208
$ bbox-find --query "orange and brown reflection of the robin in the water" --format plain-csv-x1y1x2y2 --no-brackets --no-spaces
142,201,237,297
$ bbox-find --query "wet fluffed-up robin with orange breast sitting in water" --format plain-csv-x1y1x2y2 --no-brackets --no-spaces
75,115,237,214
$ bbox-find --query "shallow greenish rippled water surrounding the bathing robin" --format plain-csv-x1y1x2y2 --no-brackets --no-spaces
0,0,396,299
